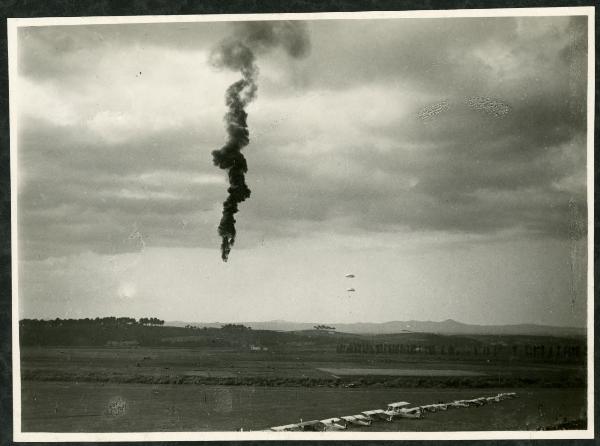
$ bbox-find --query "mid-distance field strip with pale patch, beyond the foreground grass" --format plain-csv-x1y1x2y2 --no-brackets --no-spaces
21,347,585,387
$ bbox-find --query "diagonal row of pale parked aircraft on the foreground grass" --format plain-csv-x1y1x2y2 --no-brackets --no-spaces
267,392,517,432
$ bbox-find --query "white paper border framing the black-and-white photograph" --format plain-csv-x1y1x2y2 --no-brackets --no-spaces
7,6,595,442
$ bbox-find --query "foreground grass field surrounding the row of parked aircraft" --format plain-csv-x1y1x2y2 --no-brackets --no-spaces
22,381,585,432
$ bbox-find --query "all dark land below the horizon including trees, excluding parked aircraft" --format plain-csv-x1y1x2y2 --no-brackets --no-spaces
21,324,586,432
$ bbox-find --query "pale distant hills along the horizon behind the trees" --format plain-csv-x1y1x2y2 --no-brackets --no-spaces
165,319,586,337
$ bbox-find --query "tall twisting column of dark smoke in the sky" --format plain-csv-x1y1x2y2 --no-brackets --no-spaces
210,22,309,262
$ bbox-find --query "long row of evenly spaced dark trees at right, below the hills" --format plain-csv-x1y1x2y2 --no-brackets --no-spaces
336,342,586,361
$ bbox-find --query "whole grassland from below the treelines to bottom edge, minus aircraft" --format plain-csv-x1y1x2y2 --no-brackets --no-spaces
21,347,586,432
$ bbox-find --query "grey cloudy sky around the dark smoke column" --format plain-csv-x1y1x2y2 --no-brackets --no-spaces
12,13,587,325
